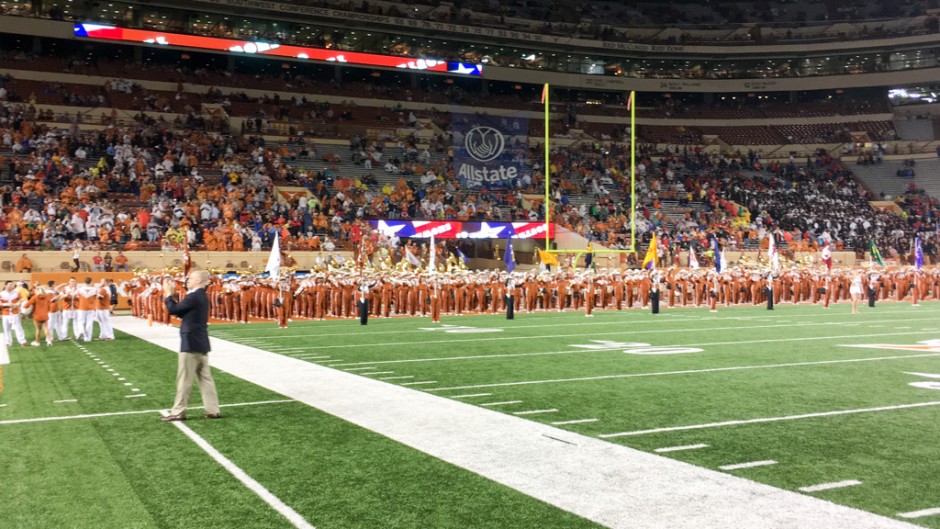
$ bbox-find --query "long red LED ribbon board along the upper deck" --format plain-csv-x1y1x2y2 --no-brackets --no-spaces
75,23,483,75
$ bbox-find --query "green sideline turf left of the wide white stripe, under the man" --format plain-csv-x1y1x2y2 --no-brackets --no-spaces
0,320,597,529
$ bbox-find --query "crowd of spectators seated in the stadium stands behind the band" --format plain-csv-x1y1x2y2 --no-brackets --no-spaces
0,50,936,266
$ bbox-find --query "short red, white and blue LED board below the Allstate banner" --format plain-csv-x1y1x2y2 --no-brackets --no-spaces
369,220,555,239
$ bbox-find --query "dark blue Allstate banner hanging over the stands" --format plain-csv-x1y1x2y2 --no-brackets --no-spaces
451,112,531,188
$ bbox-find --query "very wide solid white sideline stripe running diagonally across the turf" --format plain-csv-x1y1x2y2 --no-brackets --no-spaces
112,317,914,529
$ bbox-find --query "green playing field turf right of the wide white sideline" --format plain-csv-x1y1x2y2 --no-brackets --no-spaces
207,303,940,528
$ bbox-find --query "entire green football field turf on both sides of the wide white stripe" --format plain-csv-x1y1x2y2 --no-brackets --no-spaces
0,303,940,529
